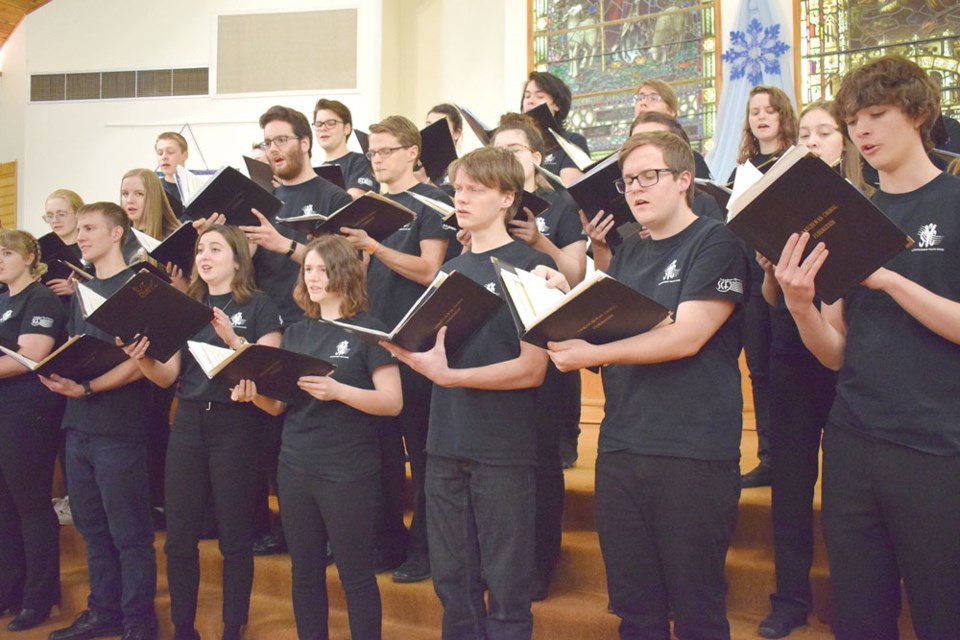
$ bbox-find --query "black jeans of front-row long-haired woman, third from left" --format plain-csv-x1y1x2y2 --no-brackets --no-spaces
163,400,260,626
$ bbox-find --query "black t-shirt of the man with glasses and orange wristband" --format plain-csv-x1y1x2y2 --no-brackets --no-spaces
367,182,456,329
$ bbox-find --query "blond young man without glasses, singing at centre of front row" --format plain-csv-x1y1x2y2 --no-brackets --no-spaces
380,147,554,640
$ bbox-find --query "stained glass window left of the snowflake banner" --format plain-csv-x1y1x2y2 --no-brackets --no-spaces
518,0,717,157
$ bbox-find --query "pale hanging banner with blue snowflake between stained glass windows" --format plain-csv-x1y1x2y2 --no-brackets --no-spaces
706,0,797,180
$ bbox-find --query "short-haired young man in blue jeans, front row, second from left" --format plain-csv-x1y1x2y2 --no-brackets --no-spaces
41,202,157,640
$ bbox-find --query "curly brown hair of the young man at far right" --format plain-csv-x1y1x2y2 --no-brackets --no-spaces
835,55,940,151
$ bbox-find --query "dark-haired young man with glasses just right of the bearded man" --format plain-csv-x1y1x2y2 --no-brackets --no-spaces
313,98,380,200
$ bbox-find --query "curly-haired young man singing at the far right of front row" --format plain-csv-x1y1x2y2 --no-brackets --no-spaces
775,56,960,640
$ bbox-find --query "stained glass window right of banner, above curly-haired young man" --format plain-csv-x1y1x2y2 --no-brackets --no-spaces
800,0,960,118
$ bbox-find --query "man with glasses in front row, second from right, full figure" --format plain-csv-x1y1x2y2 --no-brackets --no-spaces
548,132,749,640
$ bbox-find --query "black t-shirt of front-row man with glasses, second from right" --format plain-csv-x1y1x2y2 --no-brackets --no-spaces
599,218,749,460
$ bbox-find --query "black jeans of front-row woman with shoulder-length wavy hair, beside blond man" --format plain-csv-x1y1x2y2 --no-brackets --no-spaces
278,462,381,640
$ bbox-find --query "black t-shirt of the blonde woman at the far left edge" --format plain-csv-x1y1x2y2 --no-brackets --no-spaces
0,282,67,413
